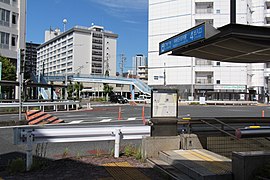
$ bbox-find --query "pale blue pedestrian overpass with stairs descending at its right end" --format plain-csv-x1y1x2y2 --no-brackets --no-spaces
39,74,151,98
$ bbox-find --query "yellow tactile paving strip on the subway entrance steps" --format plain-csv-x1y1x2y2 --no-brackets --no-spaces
175,150,230,174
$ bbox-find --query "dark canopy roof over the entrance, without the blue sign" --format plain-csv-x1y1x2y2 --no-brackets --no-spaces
170,24,270,63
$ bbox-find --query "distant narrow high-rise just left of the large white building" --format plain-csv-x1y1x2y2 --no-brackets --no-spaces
132,54,148,81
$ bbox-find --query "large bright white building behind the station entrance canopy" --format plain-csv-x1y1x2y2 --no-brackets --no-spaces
148,0,270,101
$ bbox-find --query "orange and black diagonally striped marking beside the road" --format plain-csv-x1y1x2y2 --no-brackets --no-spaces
25,110,64,125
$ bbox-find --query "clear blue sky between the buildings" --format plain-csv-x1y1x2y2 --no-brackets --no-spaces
26,0,148,71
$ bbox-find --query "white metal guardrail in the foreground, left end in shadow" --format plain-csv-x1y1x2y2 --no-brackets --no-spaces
13,125,150,170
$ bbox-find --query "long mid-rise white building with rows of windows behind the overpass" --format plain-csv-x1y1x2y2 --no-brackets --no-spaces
37,25,118,76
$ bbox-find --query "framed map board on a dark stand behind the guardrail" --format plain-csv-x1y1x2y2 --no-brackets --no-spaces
151,90,178,118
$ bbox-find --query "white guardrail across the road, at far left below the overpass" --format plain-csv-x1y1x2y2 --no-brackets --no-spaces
0,101,80,111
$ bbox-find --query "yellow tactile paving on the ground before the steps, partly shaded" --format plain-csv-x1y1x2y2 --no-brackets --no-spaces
103,162,149,180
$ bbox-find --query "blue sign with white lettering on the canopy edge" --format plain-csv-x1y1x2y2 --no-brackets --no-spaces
159,23,205,54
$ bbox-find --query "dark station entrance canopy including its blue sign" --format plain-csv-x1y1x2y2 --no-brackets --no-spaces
159,23,270,63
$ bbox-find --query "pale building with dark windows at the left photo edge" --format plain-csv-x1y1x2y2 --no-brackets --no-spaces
0,0,26,63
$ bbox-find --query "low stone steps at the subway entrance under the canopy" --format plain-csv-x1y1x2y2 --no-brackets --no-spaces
148,149,233,180
